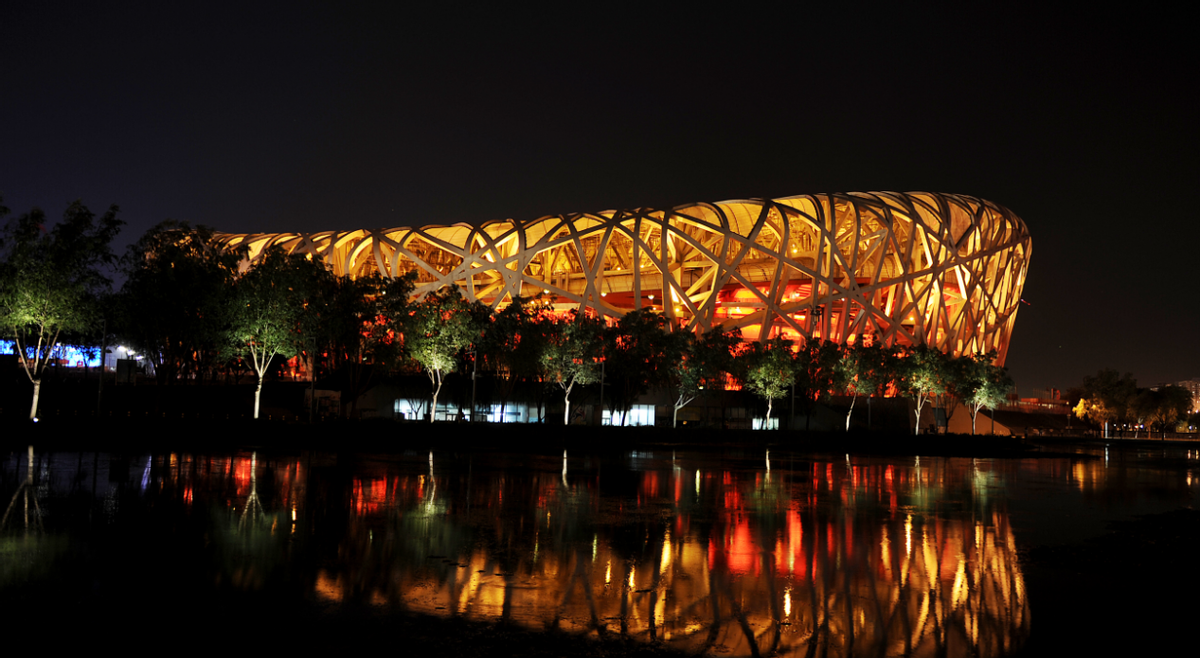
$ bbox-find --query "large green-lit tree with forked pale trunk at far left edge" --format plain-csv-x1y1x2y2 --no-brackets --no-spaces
0,201,125,420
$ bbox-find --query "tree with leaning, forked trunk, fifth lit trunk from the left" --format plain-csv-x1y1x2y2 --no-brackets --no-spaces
667,327,742,427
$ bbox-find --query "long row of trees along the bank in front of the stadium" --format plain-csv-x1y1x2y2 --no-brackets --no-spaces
0,198,1013,430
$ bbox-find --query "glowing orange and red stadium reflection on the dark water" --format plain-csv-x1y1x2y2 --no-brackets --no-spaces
321,451,1030,656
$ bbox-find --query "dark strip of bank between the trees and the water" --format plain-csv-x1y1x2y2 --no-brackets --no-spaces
0,419,1161,459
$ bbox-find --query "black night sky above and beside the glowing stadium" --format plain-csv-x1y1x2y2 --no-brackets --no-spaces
0,2,1200,395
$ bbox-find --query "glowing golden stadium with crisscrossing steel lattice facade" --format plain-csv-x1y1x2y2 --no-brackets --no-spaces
216,192,1031,364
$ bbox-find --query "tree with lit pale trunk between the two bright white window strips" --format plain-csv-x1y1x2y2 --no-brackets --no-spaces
540,311,605,425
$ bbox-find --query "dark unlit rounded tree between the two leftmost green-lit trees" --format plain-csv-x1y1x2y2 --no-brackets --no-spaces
114,220,241,383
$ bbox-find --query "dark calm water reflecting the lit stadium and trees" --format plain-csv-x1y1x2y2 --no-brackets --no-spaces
0,447,1200,657
